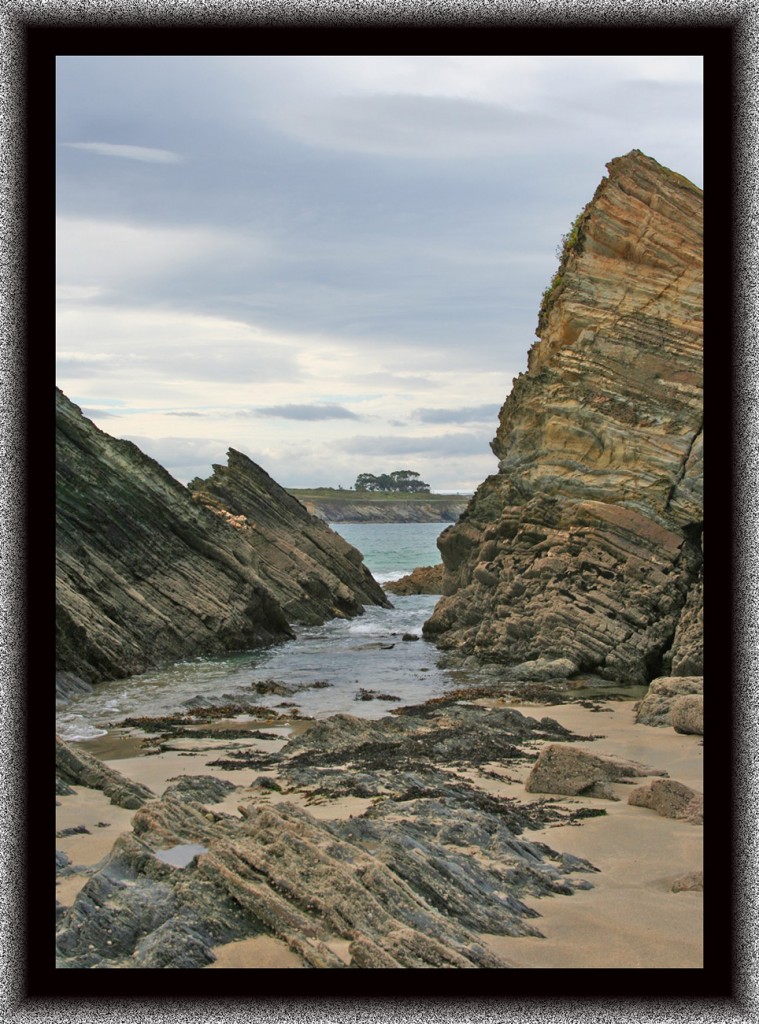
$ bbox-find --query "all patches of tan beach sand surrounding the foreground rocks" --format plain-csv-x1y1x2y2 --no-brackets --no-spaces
56,699,703,969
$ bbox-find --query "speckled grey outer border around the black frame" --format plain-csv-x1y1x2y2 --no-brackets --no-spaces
0,0,759,1024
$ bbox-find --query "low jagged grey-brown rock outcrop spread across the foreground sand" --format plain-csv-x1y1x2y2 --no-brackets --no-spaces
57,702,595,969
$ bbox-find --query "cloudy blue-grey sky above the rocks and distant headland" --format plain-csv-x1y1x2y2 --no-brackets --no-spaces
56,56,703,490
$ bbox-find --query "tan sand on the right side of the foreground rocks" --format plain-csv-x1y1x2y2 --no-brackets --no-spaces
471,702,704,968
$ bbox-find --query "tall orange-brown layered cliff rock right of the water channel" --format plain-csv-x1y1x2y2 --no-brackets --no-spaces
425,151,703,683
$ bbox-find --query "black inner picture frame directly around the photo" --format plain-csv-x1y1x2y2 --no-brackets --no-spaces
3,3,756,1021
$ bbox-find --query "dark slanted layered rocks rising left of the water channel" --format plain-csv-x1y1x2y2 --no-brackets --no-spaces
55,390,387,683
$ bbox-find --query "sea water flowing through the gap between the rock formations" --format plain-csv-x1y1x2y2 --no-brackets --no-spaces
57,523,462,740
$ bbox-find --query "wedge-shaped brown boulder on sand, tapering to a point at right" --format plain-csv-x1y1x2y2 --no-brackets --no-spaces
524,743,666,800
